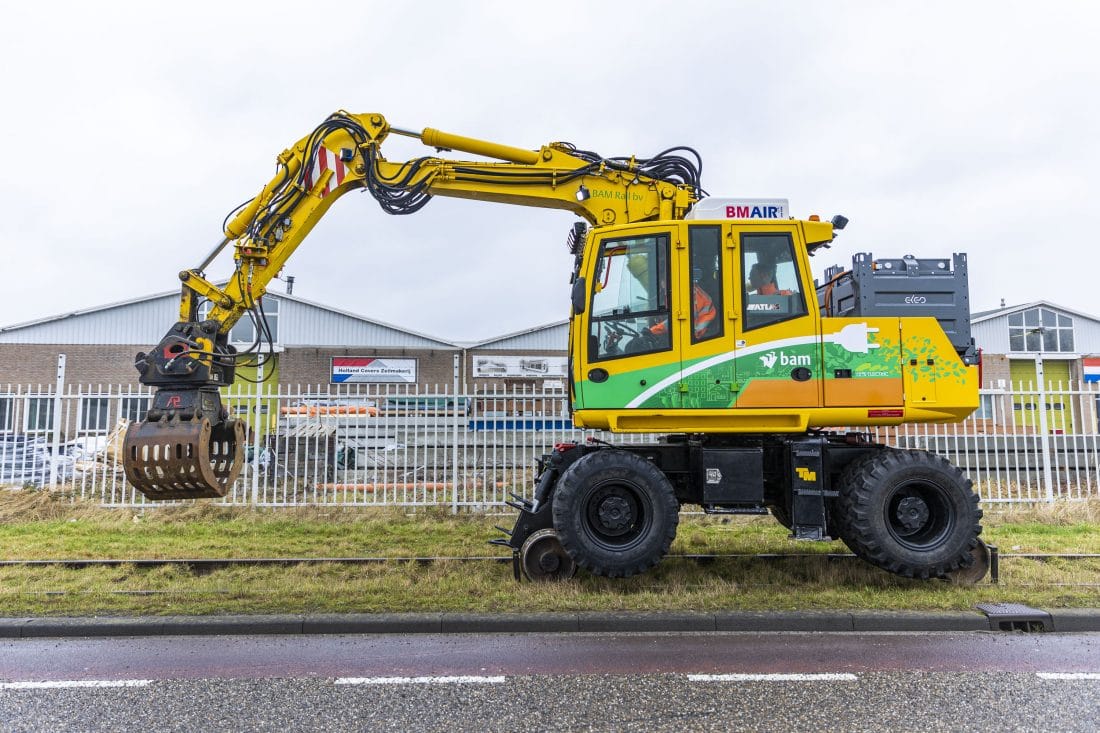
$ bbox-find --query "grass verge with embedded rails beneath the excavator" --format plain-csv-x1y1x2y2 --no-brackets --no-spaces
0,492,1100,616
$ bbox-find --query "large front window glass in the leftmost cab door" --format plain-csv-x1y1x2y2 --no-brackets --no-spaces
589,234,672,361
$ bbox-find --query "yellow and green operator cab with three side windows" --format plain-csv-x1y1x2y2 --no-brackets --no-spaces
571,218,822,422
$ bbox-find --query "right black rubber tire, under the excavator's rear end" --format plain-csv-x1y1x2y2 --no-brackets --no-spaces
836,448,982,578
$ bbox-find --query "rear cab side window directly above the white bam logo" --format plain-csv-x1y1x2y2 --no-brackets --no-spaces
741,232,807,330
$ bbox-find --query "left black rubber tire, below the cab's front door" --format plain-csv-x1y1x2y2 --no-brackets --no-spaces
553,449,680,578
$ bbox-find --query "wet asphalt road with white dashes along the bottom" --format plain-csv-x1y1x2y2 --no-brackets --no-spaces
0,633,1100,732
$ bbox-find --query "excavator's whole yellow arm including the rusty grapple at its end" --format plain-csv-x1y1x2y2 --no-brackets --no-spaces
123,111,700,499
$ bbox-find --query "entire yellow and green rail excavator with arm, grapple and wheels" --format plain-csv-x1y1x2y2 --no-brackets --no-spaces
124,111,988,580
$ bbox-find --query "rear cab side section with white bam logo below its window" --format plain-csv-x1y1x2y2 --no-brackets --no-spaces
733,221,822,408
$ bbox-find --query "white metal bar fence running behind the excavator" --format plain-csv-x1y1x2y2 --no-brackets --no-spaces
0,380,1100,501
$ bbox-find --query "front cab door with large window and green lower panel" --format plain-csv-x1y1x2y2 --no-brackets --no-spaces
572,226,682,409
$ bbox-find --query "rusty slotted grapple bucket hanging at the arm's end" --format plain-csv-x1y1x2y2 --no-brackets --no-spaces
122,417,245,501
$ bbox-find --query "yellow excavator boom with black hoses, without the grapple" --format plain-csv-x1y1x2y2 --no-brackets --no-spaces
190,112,699,332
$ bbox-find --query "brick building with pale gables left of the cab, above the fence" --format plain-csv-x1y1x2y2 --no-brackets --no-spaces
0,292,568,391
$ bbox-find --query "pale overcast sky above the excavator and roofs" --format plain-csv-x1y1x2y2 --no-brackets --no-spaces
0,0,1100,340
